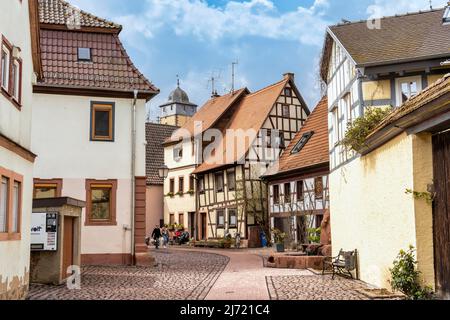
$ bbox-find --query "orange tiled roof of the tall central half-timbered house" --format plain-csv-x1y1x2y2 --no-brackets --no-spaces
194,78,290,174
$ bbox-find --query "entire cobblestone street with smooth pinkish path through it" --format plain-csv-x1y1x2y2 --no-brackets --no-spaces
28,248,390,300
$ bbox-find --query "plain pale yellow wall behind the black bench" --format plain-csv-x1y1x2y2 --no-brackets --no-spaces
330,134,434,288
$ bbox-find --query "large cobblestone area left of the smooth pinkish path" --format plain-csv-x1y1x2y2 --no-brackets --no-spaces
28,249,229,300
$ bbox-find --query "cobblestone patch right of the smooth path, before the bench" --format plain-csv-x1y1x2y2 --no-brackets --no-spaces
266,275,368,300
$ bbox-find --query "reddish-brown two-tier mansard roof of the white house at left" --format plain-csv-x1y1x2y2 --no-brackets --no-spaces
37,0,159,98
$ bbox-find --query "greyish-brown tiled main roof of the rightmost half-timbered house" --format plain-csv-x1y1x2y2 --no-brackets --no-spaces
321,9,450,79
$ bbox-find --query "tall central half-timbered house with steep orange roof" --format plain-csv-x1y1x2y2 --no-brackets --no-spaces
194,74,309,246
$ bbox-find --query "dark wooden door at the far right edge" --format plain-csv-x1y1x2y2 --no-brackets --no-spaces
433,132,450,299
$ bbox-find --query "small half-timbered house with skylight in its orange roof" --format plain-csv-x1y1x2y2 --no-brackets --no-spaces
262,97,329,244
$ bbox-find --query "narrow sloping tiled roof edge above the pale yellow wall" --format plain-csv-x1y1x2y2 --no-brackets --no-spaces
368,73,450,139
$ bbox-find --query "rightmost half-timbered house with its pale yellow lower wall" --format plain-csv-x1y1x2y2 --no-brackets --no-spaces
321,7,450,292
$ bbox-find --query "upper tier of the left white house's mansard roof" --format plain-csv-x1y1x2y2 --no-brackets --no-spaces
39,0,122,30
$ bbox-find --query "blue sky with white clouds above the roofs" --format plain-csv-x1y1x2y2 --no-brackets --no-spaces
68,0,447,120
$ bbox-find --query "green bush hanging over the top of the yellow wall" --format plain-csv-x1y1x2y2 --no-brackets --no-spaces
340,107,392,153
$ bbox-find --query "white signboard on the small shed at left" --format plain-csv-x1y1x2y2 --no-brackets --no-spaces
31,212,59,251
